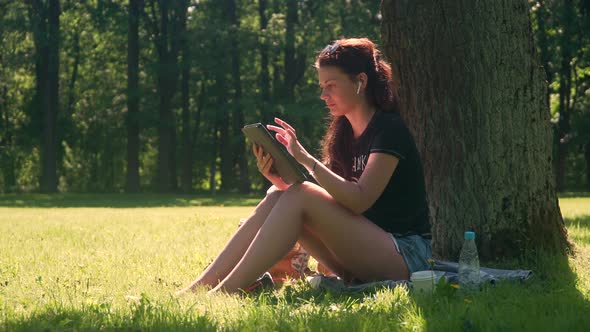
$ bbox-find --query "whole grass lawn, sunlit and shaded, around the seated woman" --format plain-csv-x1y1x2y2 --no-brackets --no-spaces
0,194,590,331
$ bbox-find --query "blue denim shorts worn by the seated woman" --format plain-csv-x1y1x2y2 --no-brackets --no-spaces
389,234,432,275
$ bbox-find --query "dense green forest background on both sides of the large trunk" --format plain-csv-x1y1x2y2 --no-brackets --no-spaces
0,0,590,192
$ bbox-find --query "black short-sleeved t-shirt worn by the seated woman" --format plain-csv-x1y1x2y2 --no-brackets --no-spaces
352,111,430,238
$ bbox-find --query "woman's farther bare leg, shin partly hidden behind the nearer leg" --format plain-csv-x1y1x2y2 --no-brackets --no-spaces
178,186,282,293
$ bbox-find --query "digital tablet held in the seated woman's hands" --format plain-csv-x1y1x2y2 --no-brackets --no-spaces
242,123,307,184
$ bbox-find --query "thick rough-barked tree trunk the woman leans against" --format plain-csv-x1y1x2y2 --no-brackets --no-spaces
381,0,568,261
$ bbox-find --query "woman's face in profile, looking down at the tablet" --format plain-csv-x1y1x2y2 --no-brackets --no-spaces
318,66,360,116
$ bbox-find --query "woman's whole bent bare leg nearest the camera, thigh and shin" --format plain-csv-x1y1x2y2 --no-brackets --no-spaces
214,183,408,292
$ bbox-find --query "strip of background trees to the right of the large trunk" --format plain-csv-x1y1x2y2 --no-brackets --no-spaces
530,0,590,191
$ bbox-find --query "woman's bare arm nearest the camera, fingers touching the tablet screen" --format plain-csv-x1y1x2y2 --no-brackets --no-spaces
268,119,399,214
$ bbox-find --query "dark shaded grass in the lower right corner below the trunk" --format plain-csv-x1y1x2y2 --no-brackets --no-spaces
414,244,590,331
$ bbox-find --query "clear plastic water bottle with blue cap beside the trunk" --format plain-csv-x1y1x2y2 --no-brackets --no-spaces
459,232,480,291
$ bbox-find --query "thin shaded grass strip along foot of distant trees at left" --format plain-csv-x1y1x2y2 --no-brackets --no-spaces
0,193,263,208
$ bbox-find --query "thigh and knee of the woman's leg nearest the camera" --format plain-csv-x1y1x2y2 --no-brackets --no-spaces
281,182,409,281
